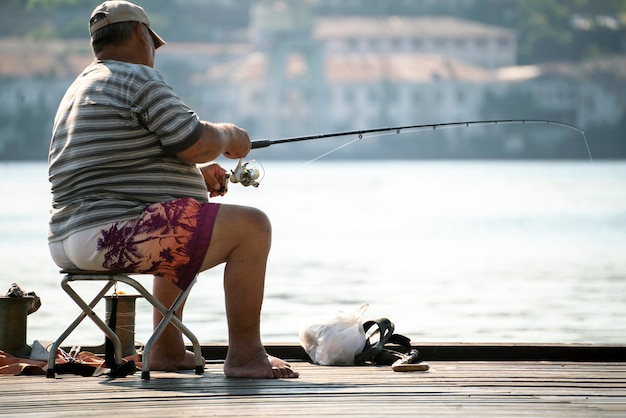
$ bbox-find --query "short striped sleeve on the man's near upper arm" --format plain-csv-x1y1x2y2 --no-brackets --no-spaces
131,81,203,155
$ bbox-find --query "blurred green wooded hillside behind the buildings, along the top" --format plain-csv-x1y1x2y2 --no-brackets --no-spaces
0,0,626,64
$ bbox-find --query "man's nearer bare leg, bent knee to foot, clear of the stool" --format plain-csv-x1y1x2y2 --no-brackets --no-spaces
202,205,298,378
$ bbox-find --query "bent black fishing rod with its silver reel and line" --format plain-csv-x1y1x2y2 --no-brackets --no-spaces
226,119,593,187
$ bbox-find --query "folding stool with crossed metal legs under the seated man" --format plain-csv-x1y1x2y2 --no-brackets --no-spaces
46,271,204,379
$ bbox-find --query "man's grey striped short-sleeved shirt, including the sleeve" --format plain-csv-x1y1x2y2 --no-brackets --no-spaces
48,60,208,242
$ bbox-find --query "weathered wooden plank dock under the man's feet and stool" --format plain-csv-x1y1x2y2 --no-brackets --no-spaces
0,345,626,418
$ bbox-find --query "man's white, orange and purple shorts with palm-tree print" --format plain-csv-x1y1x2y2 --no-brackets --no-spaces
50,198,220,290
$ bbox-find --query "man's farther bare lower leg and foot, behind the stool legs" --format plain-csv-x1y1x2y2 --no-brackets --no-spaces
150,276,195,371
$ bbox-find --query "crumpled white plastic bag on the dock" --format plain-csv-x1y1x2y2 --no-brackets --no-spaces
300,304,368,366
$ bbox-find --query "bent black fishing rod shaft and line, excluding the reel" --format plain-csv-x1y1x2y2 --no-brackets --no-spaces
252,119,593,164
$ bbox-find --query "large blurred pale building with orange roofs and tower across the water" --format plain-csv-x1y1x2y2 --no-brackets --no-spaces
194,1,517,144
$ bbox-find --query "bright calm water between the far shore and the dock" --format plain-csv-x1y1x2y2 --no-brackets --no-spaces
0,161,626,344
